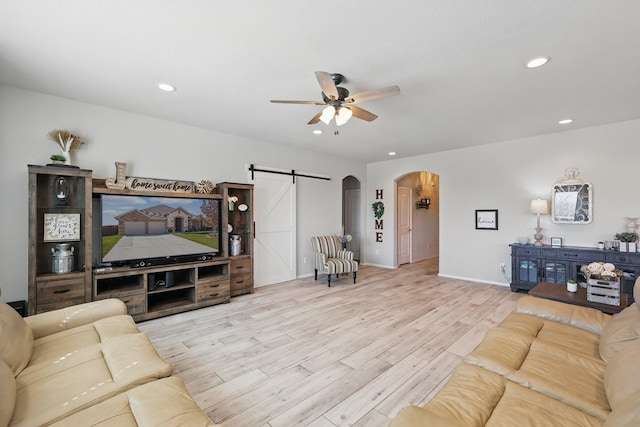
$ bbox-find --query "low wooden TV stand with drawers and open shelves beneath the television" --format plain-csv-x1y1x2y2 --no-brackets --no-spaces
93,258,230,321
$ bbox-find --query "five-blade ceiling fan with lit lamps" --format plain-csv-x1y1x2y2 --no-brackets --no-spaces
271,71,400,126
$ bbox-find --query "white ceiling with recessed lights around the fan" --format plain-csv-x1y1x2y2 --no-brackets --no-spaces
0,0,640,162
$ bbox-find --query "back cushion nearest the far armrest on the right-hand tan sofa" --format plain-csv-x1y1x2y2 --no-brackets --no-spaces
600,306,640,363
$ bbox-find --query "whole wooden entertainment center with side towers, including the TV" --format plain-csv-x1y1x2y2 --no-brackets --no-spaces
28,165,254,321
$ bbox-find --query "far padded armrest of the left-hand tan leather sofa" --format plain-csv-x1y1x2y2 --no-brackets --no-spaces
24,298,127,339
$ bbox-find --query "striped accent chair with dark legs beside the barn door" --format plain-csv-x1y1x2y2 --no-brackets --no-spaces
311,236,358,287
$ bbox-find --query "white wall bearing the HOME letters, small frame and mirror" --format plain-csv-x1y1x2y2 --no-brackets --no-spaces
363,120,640,284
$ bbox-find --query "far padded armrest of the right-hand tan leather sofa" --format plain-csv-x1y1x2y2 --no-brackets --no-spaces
514,295,611,335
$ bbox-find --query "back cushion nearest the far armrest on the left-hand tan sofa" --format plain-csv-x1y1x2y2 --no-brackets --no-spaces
0,301,33,376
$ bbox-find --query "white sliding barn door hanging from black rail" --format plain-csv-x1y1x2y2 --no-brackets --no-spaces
253,172,296,287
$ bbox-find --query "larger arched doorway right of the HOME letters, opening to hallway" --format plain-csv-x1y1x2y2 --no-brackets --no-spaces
395,171,440,268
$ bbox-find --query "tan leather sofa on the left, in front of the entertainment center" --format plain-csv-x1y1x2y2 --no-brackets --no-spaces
0,299,219,427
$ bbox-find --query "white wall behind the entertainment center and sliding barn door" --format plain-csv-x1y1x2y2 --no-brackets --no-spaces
0,85,365,301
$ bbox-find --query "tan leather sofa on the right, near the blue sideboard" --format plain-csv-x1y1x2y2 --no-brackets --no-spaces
391,279,640,427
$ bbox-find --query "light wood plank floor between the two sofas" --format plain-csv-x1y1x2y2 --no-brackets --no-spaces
139,261,521,427
